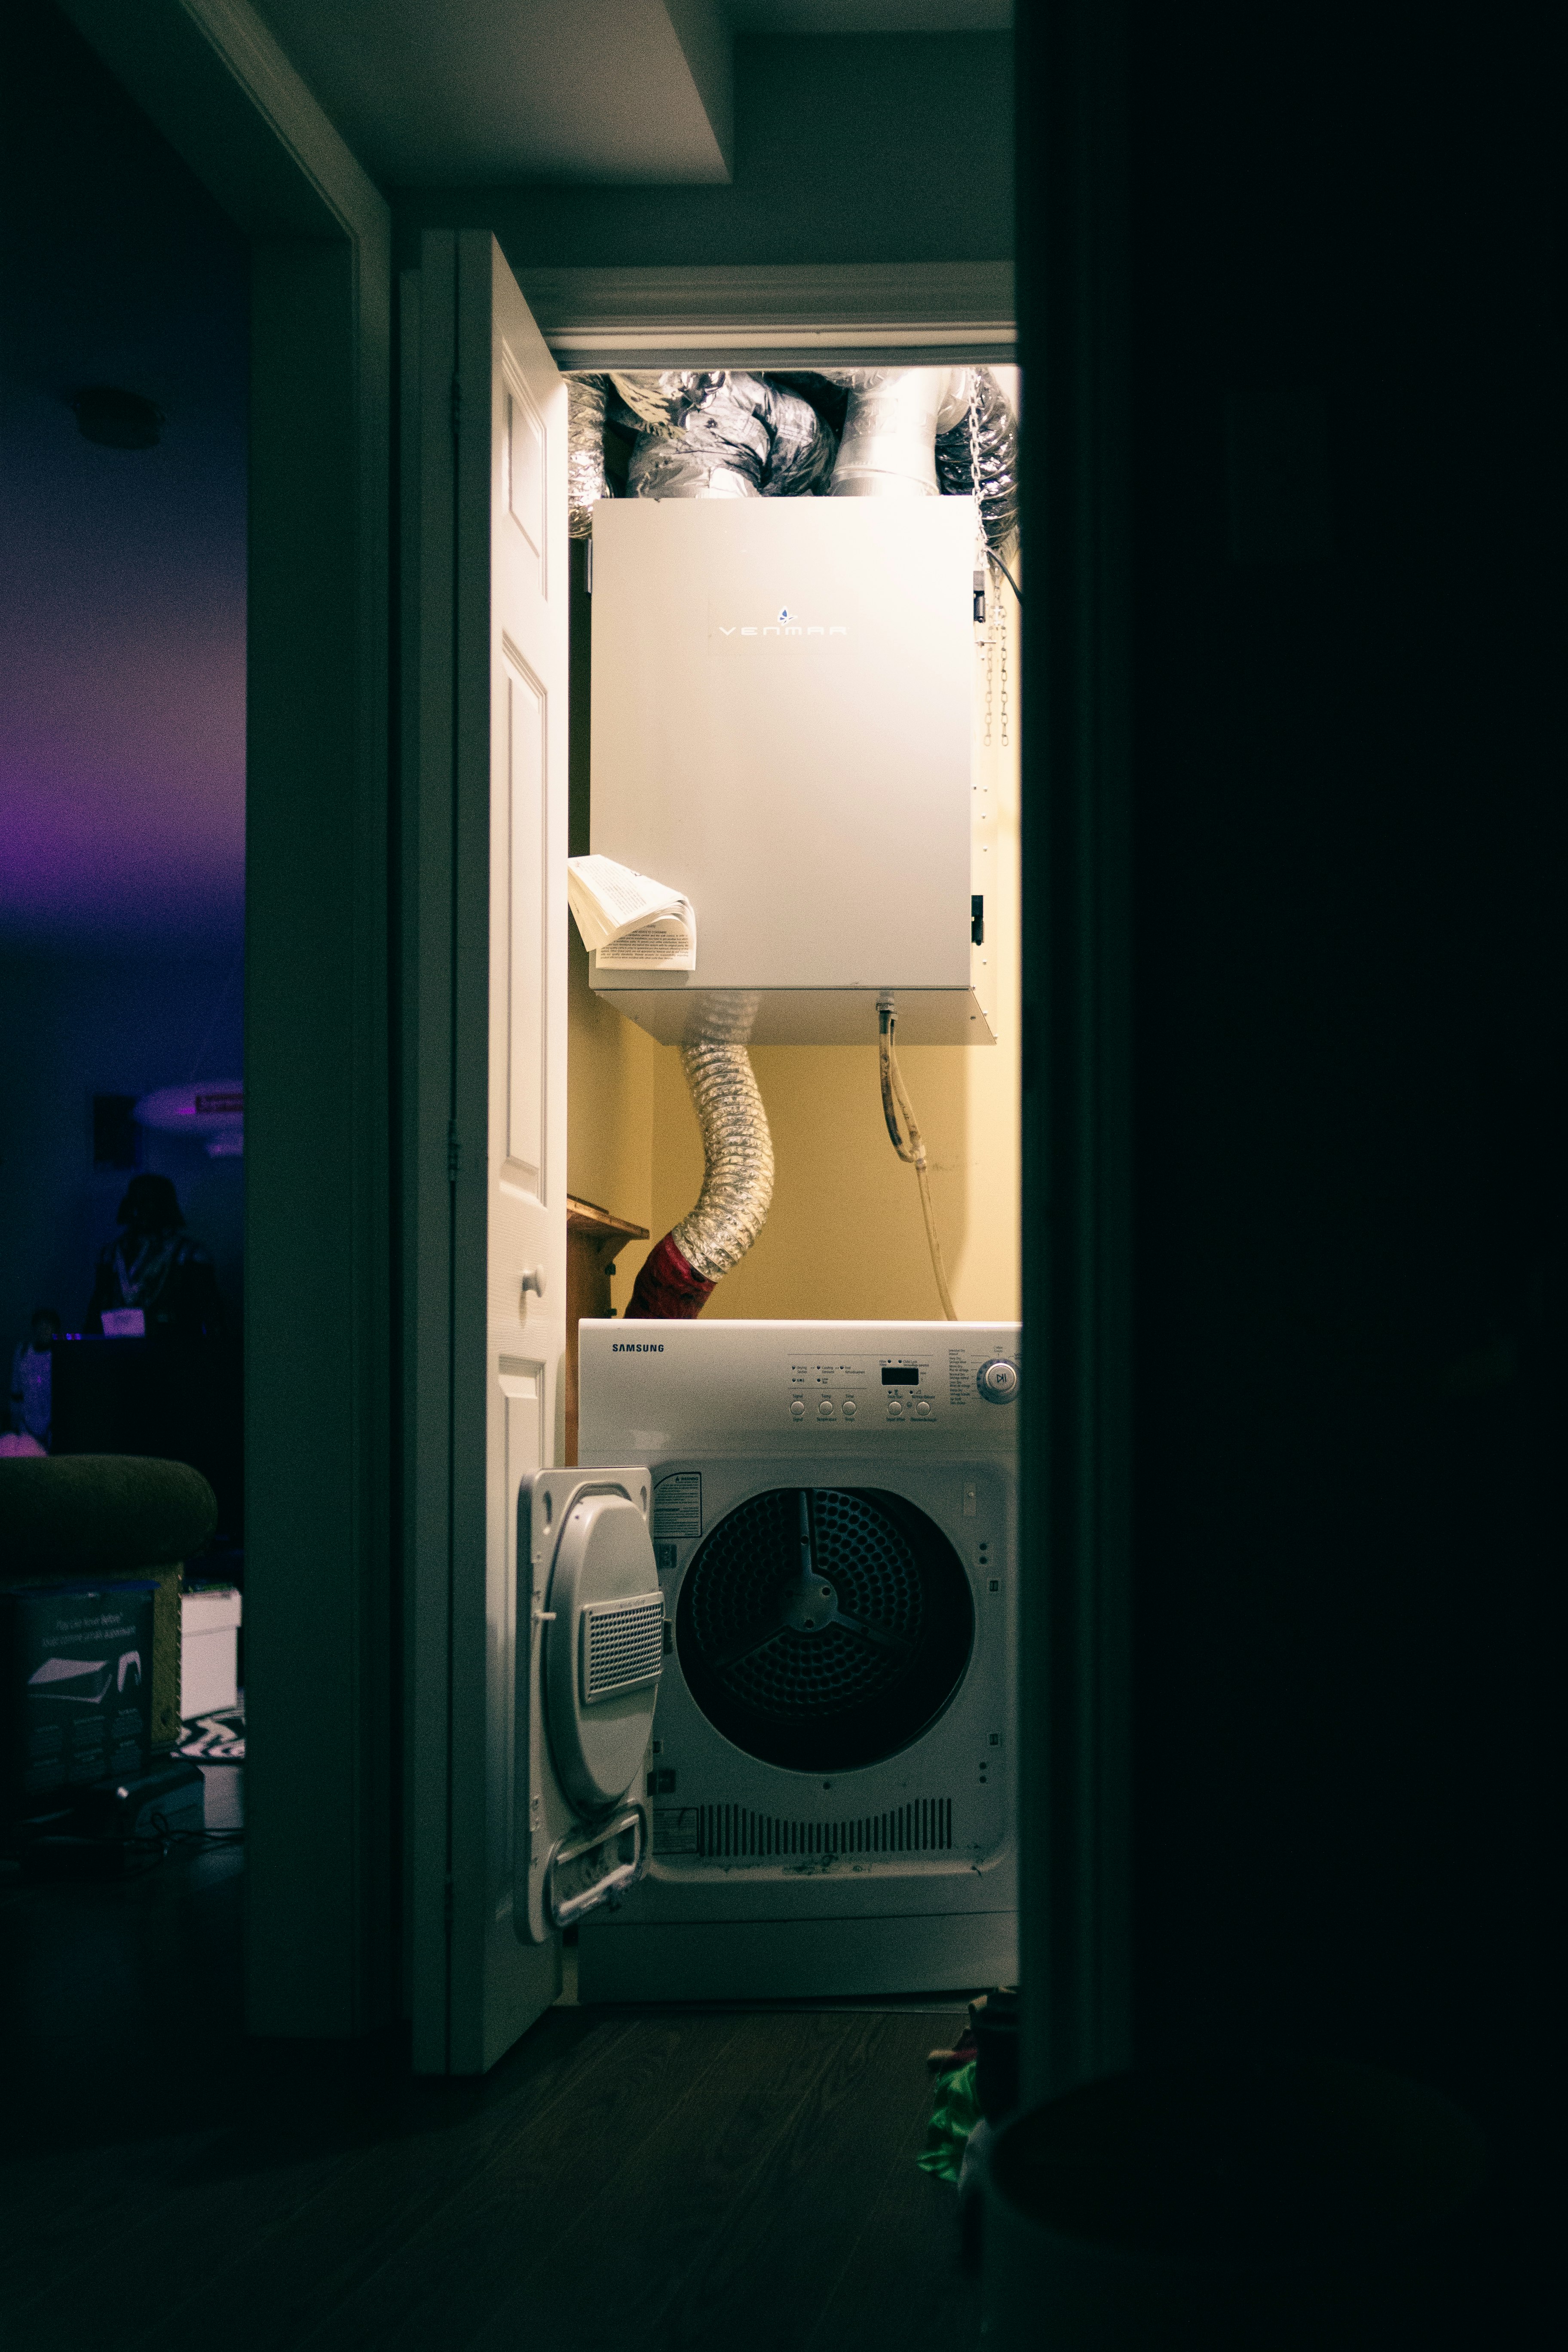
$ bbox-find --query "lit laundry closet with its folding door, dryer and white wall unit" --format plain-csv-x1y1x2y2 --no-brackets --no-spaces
402,235,1023,2072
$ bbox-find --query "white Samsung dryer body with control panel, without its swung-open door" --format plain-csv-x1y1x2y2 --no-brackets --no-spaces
578,1322,1018,2002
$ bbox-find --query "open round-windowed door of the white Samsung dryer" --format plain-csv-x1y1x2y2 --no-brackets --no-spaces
512,1470,665,1945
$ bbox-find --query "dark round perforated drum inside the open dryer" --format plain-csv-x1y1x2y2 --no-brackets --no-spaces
675,1486,976,1771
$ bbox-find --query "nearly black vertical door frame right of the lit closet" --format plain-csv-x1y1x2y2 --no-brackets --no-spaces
1016,0,1136,2103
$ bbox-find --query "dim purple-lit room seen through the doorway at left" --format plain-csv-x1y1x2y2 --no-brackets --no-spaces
0,9,247,1834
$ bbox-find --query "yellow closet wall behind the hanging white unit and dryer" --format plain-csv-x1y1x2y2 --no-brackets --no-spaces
569,569,1018,1322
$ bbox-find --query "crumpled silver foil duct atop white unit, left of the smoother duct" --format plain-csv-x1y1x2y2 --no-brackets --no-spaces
628,372,835,499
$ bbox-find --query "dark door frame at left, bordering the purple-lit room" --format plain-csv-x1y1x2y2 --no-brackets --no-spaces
64,0,397,2034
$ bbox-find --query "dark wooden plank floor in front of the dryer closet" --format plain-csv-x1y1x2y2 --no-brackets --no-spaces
0,1825,980,2352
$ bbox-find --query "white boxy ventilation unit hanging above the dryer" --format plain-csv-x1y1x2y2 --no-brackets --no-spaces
590,499,992,1044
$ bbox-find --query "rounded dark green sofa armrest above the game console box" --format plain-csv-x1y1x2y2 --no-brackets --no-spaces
0,1454,219,1580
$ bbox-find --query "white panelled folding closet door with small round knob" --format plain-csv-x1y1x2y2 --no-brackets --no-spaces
400,233,567,2074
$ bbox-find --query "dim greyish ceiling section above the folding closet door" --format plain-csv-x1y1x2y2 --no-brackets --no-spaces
256,0,1011,188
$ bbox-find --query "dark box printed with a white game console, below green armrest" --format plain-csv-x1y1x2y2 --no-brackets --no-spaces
0,1583,153,1813
